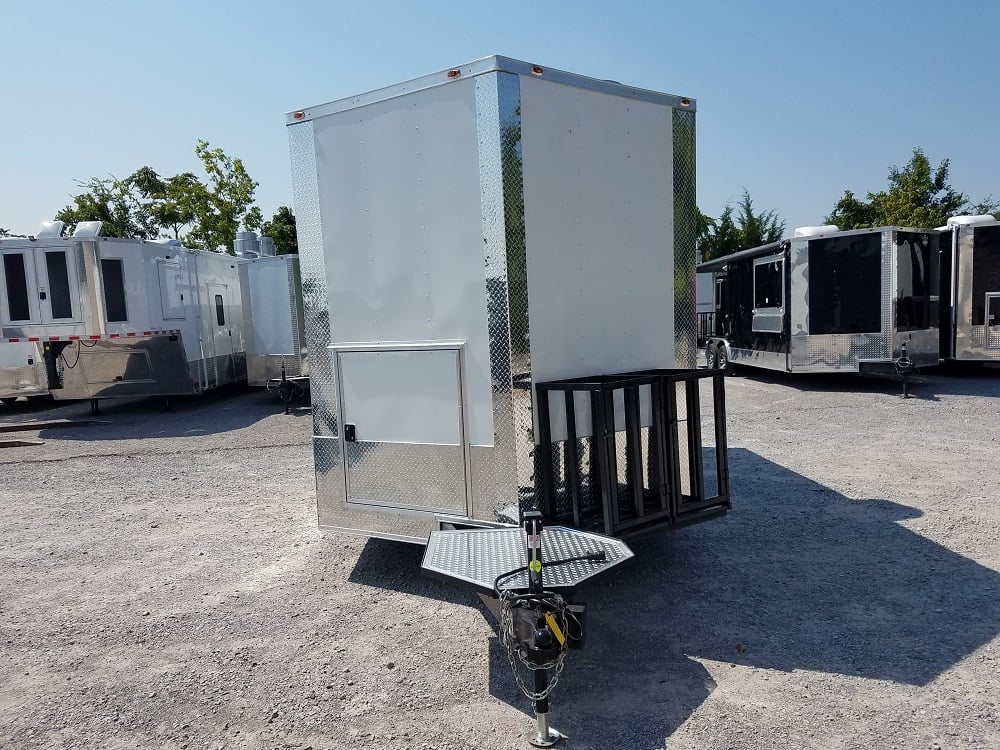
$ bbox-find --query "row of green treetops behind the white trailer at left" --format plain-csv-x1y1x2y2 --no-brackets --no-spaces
56,140,264,253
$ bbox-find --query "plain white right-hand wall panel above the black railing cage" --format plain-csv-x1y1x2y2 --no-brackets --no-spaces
521,77,675,382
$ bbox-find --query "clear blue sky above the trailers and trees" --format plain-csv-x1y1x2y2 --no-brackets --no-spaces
0,0,1000,233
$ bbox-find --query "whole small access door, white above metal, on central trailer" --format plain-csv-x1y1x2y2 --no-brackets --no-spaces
333,344,468,516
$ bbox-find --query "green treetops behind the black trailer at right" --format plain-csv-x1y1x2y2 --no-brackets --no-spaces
826,148,998,229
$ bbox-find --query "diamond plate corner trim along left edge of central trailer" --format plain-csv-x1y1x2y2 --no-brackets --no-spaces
288,122,339,437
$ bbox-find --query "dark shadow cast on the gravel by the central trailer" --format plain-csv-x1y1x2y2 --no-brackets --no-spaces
340,449,1000,748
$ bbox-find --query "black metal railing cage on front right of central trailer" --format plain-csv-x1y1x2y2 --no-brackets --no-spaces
535,370,730,536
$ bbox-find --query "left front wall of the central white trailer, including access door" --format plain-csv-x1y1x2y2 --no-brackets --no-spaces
290,78,500,539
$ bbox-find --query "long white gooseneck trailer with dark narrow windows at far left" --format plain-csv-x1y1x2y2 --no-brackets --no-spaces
0,225,246,400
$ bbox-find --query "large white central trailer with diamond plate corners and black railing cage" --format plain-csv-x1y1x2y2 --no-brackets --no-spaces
287,57,728,542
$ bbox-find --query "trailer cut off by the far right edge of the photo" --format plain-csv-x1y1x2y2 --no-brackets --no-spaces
941,215,1000,362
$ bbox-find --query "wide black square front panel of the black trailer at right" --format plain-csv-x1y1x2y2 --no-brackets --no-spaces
808,232,882,334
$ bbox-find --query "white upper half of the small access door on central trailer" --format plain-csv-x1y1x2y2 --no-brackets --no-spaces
338,349,462,445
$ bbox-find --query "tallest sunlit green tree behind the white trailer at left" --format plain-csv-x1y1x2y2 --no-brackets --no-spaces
182,140,263,254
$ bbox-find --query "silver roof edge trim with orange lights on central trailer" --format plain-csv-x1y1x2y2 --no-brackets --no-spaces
285,55,697,125
